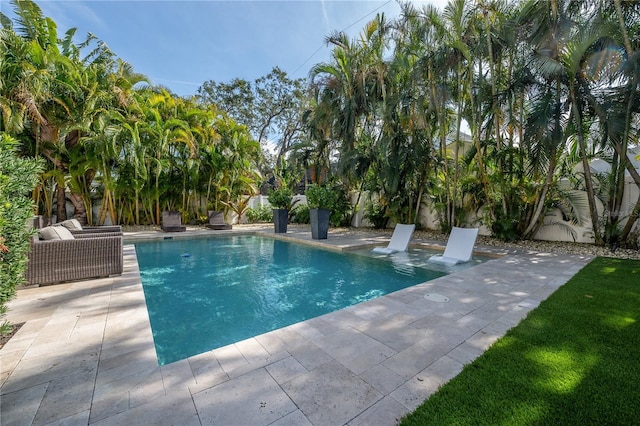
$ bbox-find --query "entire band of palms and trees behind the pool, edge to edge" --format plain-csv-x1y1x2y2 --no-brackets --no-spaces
0,0,640,247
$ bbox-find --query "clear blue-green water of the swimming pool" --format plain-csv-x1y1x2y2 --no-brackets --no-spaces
136,236,445,365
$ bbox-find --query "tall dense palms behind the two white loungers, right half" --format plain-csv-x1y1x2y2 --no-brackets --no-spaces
304,0,640,245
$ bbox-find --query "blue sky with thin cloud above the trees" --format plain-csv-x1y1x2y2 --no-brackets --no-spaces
0,0,446,96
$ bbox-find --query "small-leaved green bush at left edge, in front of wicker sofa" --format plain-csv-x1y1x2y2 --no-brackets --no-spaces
0,133,42,334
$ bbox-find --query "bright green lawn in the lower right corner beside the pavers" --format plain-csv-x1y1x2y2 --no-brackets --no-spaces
401,258,640,426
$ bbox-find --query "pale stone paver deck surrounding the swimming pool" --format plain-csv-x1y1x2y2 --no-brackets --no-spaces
0,228,591,426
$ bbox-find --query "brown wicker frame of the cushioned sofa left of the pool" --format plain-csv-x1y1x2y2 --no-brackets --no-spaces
26,234,123,285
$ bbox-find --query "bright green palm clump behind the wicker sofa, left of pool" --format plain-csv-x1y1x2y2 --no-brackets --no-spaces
0,0,262,224
